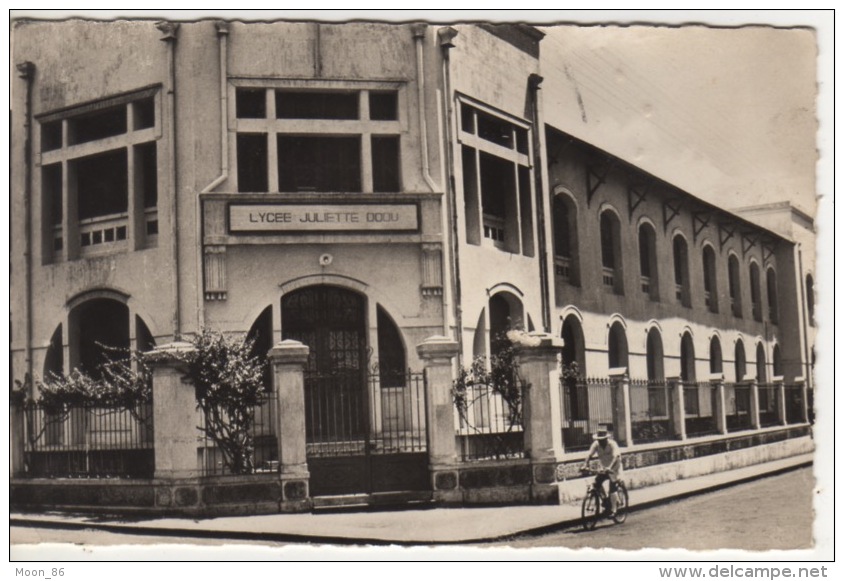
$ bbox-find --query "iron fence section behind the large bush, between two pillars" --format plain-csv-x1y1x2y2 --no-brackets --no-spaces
197,392,279,476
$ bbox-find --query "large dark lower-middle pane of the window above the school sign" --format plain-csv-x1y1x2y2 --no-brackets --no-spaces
278,135,361,192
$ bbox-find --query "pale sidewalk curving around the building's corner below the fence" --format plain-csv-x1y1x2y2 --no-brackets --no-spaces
9,454,813,545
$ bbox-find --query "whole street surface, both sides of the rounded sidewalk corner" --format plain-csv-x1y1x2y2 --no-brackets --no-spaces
10,468,813,559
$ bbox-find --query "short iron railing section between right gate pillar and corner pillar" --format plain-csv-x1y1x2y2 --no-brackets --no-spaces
456,384,525,460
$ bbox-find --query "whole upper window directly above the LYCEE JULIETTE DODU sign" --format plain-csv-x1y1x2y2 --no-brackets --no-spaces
235,87,403,192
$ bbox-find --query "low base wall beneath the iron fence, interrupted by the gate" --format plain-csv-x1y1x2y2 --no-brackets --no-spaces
10,425,814,516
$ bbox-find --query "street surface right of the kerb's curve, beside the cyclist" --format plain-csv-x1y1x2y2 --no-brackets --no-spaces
486,468,814,551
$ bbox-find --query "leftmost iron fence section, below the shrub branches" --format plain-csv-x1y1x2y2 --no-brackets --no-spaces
23,402,155,478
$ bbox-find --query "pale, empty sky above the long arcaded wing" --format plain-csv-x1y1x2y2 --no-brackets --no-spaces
541,26,817,215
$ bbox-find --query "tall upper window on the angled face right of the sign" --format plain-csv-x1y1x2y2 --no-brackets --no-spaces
459,100,535,256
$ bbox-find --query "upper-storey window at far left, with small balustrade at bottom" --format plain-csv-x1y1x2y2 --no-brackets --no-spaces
36,88,161,262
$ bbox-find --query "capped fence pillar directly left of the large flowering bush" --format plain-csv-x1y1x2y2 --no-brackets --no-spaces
147,341,200,480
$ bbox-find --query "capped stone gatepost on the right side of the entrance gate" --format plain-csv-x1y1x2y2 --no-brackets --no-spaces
416,336,462,503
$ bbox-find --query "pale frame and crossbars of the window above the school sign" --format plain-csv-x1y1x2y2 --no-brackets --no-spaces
228,78,409,194
